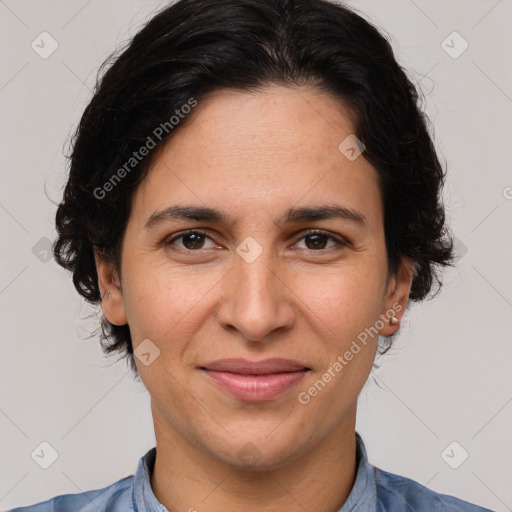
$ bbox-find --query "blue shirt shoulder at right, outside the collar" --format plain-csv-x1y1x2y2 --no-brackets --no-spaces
374,467,492,512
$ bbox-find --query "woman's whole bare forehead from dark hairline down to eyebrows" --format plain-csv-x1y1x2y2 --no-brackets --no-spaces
130,86,382,230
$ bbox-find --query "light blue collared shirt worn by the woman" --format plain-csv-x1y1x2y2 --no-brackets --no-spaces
8,433,492,512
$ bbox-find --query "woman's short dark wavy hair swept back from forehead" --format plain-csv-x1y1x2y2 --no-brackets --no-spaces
53,0,453,375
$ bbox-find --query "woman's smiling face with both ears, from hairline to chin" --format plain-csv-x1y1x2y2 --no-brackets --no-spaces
96,86,411,468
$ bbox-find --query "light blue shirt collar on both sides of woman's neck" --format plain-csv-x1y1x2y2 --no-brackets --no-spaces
132,432,377,512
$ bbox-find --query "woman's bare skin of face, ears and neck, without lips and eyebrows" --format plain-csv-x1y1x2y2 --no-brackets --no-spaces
96,86,412,512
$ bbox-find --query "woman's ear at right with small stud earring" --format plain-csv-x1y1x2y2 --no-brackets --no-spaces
379,258,415,336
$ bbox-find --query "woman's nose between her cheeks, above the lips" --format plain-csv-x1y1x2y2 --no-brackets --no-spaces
217,248,295,342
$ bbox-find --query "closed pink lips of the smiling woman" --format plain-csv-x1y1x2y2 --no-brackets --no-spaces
200,358,310,402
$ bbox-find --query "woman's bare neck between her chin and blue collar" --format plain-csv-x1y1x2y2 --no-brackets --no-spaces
151,405,357,512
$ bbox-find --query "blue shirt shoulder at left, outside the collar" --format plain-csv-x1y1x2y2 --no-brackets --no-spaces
7,475,133,512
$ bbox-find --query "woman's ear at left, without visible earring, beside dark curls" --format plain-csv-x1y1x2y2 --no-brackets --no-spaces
94,248,128,325
